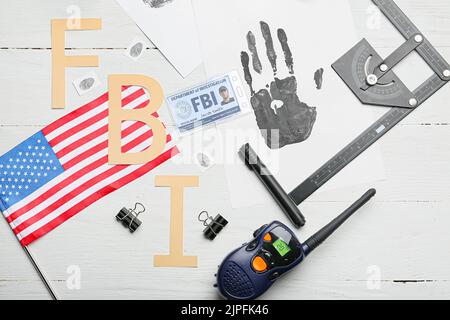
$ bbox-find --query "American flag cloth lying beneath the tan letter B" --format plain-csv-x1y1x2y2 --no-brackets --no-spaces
0,87,179,246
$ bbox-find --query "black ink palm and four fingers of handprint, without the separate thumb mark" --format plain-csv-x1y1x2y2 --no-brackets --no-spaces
241,21,317,149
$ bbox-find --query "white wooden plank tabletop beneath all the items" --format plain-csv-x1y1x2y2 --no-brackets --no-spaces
0,0,450,299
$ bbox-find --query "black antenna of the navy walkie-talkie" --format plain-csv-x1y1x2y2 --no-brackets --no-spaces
303,189,376,255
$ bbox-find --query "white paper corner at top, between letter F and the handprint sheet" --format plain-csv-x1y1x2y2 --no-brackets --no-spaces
117,0,202,77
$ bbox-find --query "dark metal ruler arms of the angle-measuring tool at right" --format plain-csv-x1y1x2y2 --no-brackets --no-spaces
289,0,450,205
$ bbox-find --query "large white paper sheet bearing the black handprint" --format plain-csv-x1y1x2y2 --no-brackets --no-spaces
193,0,384,207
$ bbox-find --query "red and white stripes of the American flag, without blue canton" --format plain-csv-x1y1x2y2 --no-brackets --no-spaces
0,87,179,246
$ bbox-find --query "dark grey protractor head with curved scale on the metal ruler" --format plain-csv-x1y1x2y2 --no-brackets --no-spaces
332,39,413,108
